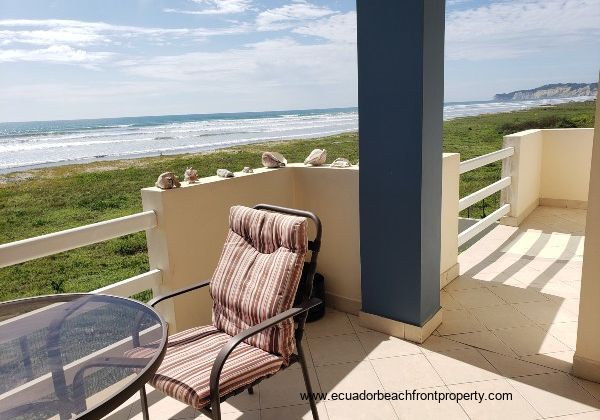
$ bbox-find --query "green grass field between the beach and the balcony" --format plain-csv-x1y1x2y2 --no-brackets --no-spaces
0,102,594,301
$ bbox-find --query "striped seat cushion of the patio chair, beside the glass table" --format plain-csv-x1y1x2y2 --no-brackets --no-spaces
150,325,283,409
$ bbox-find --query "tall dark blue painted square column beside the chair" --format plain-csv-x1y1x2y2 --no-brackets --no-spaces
357,0,444,326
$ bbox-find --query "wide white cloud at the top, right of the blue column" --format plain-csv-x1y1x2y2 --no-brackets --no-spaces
446,0,600,60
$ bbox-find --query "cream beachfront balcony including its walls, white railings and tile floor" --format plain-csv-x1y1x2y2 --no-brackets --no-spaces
0,129,600,419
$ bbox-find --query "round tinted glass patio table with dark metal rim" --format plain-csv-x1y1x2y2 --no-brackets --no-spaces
0,294,167,420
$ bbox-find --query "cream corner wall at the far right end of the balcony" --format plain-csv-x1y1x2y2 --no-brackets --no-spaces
502,128,594,226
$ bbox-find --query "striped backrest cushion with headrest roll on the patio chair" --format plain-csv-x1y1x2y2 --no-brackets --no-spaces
210,206,308,364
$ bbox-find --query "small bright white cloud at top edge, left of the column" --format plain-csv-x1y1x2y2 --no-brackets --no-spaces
256,0,336,31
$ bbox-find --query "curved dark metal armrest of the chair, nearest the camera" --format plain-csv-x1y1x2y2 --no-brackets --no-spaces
210,298,323,407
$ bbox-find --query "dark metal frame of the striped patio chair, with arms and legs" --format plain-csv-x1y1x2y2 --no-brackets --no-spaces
140,204,323,420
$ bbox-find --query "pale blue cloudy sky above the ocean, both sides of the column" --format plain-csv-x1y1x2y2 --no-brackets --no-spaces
0,0,600,121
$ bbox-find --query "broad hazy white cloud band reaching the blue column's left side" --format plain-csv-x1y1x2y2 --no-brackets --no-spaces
119,38,356,88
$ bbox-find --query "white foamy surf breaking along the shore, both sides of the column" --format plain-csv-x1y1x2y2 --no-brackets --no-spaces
0,97,590,176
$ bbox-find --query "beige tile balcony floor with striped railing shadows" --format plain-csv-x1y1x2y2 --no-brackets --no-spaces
105,207,600,420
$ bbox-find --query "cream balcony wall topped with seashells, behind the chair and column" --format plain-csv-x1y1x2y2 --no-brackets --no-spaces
142,154,459,332
